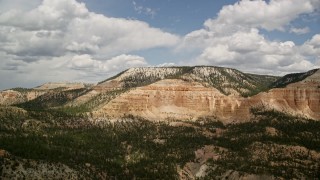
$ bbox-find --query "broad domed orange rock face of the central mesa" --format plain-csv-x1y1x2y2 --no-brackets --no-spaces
93,79,249,121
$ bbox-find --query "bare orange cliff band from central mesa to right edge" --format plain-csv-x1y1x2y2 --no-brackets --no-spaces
93,70,320,123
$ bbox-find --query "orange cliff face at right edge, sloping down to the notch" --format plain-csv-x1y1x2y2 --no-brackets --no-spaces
249,70,320,119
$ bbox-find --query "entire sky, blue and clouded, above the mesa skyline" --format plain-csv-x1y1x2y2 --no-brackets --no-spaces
0,0,320,90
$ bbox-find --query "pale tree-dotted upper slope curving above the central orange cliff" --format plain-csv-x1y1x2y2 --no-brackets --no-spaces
66,66,279,114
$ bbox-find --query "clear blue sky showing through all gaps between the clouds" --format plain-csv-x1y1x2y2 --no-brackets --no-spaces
81,0,320,41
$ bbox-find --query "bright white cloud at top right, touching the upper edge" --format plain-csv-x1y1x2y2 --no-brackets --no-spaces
205,0,319,32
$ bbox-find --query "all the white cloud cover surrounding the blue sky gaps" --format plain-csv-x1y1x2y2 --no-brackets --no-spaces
0,0,320,89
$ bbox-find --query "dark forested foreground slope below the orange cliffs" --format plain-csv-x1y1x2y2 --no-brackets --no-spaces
0,107,320,179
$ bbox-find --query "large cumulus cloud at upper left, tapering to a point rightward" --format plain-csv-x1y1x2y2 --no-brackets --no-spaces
0,0,179,59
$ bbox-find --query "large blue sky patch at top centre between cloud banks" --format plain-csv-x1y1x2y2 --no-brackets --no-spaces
83,0,236,35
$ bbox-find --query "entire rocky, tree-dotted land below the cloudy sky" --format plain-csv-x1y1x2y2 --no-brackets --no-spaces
0,66,320,180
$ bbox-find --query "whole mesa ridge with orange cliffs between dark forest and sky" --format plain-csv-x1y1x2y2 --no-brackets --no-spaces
0,66,320,123
